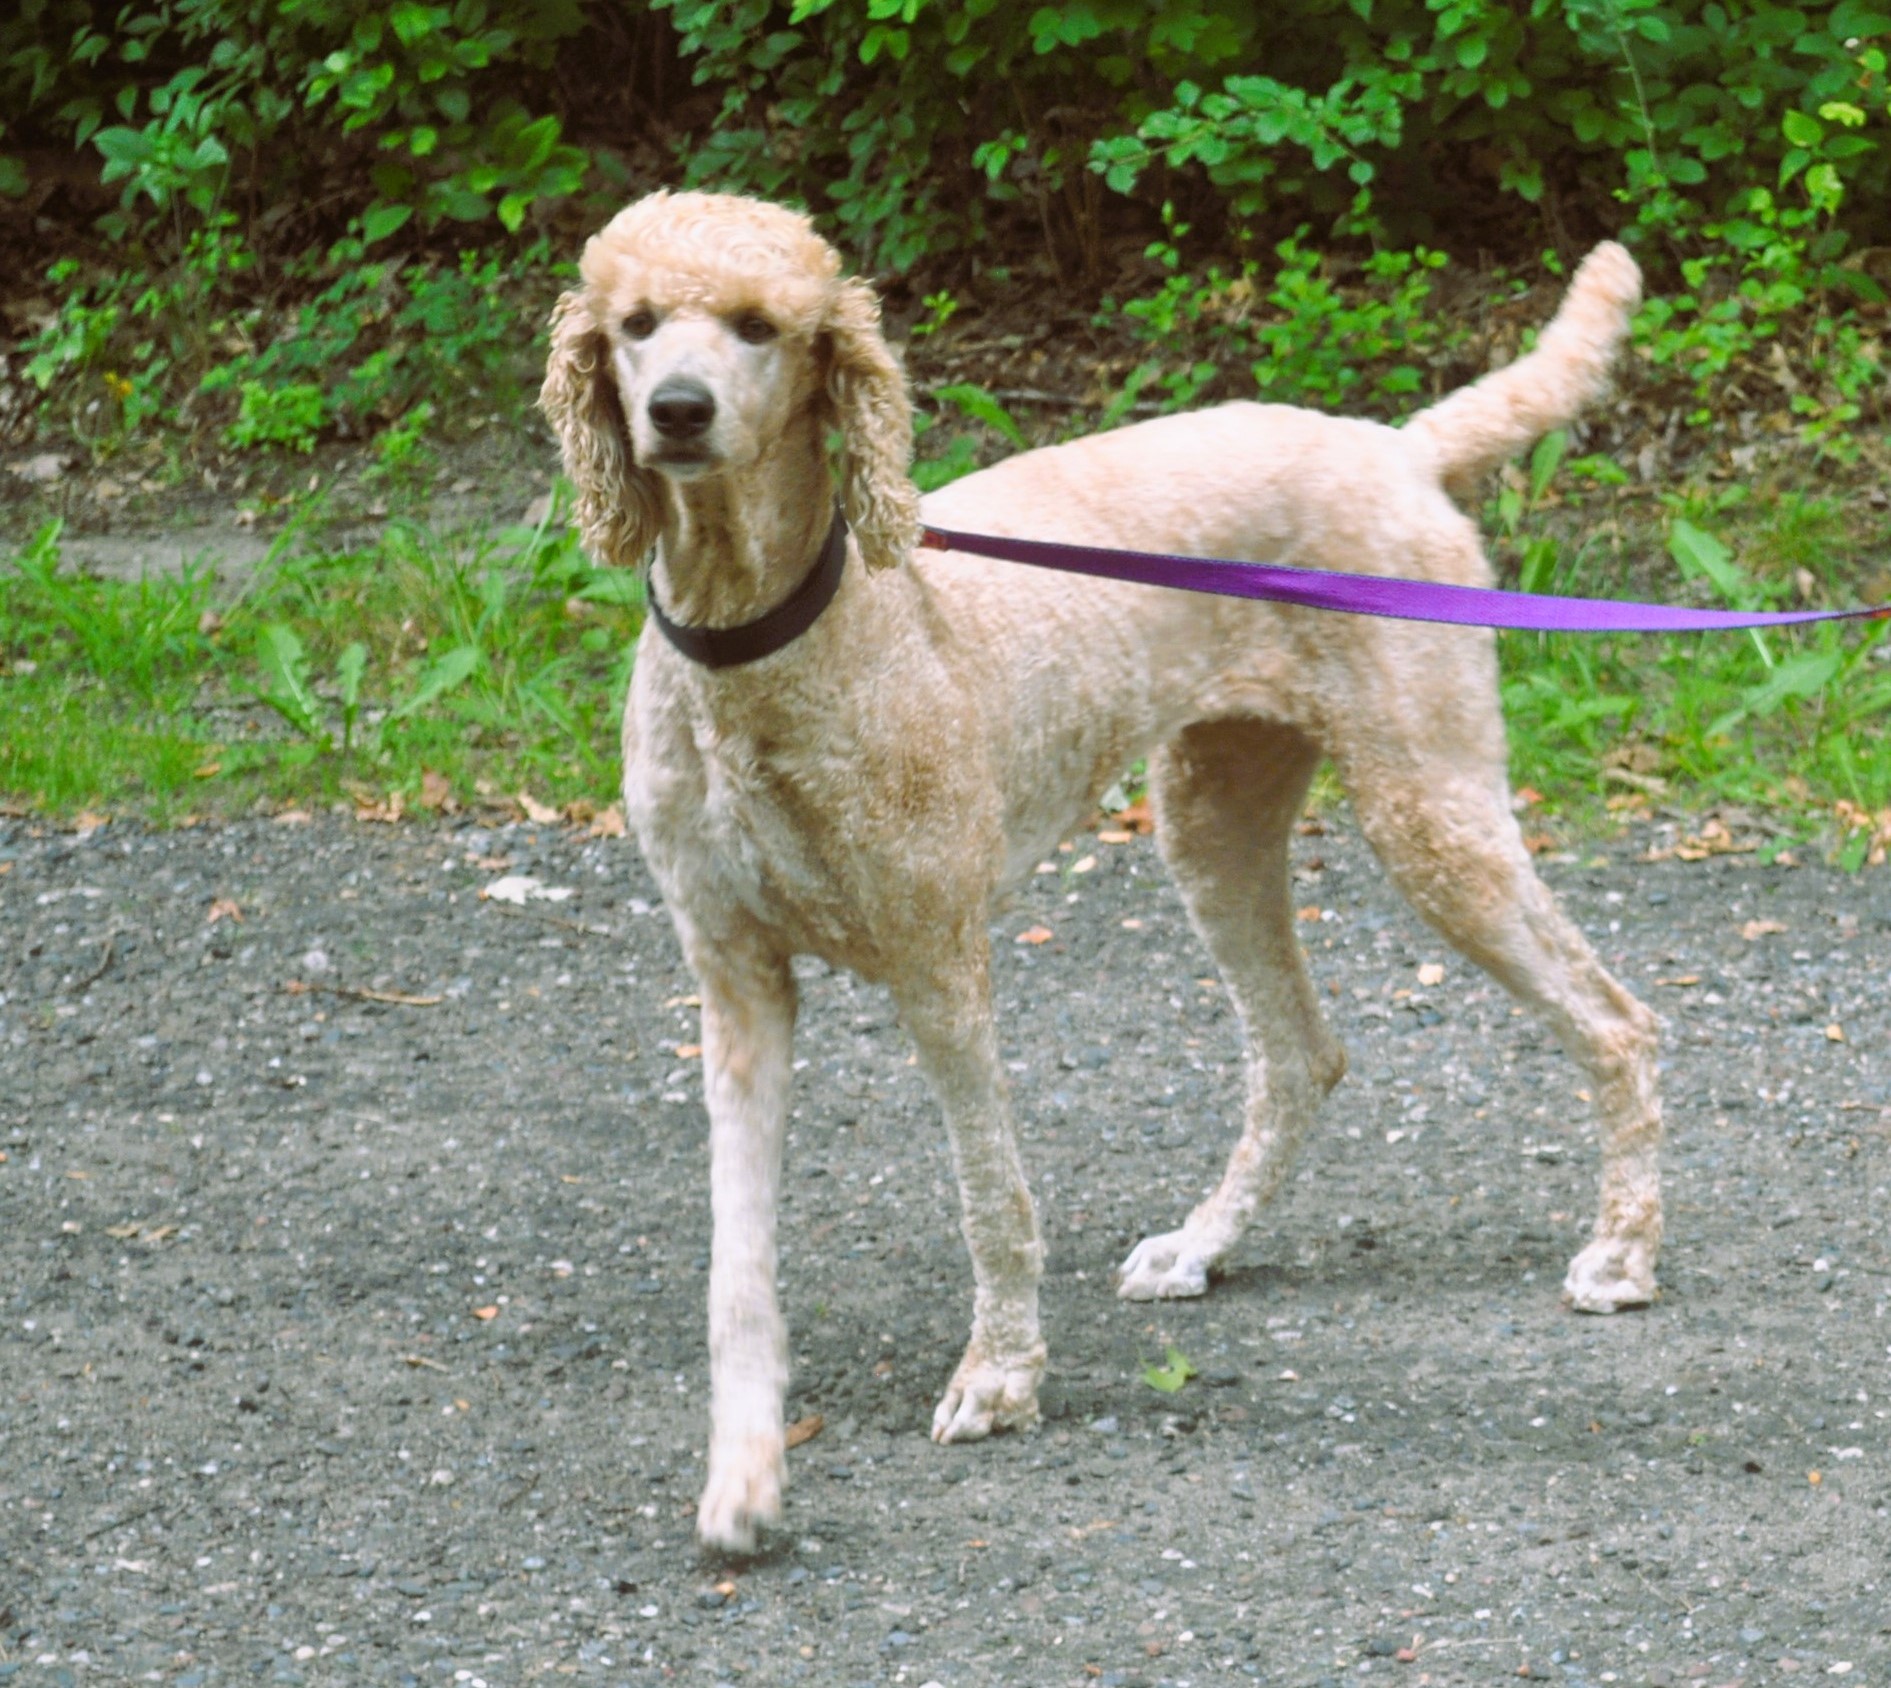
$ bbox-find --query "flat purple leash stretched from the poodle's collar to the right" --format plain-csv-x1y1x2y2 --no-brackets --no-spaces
919,527,1891,633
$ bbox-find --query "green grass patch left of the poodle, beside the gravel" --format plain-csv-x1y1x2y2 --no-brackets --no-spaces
0,499,641,820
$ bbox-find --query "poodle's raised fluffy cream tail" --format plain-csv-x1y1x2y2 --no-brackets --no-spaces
1403,240,1641,491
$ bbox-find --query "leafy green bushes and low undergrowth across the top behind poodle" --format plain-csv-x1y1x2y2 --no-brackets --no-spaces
0,0,1891,452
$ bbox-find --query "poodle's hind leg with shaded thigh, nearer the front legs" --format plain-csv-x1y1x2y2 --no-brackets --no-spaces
1116,720,1346,1300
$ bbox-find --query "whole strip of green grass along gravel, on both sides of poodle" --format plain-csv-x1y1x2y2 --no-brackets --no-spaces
0,448,1891,866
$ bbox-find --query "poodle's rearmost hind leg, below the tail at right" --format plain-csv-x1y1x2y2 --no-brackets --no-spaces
1354,771,1662,1314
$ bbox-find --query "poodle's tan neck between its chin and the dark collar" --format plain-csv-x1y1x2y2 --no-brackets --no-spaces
651,418,834,628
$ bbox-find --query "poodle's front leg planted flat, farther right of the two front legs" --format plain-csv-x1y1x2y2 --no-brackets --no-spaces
894,943,1044,1442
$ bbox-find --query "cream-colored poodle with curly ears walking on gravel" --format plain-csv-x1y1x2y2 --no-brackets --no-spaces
541,193,1662,1548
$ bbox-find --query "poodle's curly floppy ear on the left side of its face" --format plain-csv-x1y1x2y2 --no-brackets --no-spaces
539,293,662,567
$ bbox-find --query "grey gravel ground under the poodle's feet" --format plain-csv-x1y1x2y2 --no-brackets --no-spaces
0,817,1891,1688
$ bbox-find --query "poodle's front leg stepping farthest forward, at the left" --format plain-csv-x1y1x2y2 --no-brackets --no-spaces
686,943,794,1552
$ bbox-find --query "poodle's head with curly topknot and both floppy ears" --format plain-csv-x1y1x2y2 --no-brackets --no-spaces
539,193,919,567
